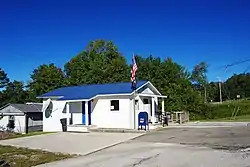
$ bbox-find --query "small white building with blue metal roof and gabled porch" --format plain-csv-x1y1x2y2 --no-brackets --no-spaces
38,81,166,132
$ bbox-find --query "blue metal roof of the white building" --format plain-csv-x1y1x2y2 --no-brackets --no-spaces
38,81,147,100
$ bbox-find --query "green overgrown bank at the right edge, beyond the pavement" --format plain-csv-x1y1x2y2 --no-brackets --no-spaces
190,101,250,120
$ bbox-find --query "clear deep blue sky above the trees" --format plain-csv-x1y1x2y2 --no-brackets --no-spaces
0,0,250,81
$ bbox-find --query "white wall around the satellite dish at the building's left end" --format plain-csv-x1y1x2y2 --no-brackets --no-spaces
43,100,69,132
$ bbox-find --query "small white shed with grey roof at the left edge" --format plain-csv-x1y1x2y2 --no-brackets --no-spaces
0,103,43,133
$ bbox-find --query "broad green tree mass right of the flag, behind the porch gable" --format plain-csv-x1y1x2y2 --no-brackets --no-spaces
136,55,200,111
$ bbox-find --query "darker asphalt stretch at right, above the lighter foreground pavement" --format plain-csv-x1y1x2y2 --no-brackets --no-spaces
135,126,250,150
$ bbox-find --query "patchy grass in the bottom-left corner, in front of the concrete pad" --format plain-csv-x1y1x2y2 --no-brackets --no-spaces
0,145,74,167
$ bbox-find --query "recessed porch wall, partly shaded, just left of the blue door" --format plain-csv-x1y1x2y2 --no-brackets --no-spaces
69,102,82,124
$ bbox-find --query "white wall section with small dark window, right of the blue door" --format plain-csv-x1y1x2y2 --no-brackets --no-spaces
91,96,133,129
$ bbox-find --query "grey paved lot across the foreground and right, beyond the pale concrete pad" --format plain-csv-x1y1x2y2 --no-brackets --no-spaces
42,127,250,167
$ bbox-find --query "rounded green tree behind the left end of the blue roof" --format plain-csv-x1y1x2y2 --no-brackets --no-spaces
27,64,66,101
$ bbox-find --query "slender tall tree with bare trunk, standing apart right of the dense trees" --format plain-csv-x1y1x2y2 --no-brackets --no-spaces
191,62,208,103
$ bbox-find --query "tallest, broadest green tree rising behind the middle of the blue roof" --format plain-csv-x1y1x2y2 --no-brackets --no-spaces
64,40,129,85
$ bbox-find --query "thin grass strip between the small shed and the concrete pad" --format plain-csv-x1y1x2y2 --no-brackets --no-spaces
0,131,52,140
